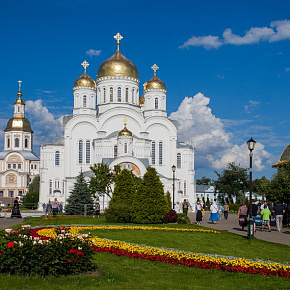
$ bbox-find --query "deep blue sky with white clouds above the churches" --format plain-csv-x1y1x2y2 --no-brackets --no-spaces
0,0,290,178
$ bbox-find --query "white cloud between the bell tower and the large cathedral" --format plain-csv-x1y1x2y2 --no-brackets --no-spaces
25,100,63,145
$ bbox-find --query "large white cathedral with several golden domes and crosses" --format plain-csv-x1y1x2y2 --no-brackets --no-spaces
39,33,195,208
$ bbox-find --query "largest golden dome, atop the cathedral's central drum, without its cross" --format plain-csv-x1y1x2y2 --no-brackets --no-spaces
97,50,139,79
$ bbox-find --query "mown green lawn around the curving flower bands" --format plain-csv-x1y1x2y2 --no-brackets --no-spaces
0,217,290,289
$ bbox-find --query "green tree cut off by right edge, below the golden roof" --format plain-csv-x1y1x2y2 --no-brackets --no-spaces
266,165,290,203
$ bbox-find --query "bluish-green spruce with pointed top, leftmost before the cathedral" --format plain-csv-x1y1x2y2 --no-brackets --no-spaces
65,171,93,215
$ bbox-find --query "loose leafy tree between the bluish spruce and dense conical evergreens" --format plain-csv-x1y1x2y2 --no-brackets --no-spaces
90,163,121,198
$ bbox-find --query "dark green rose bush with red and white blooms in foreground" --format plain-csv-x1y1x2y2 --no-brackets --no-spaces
0,227,95,276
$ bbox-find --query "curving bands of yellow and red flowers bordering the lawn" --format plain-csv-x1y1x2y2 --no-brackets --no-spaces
33,226,290,278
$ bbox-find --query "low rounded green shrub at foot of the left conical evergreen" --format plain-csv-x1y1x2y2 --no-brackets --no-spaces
105,203,131,223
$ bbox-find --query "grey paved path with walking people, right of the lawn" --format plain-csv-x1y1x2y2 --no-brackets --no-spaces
188,212,290,246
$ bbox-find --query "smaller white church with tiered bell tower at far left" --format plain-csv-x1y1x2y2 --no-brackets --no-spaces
0,81,40,203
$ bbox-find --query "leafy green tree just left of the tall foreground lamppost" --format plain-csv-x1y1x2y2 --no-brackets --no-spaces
214,162,249,203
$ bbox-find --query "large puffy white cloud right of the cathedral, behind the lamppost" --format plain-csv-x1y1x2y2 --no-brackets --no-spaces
170,93,271,171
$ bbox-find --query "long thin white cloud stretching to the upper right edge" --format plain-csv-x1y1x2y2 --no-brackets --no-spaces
179,19,290,49
